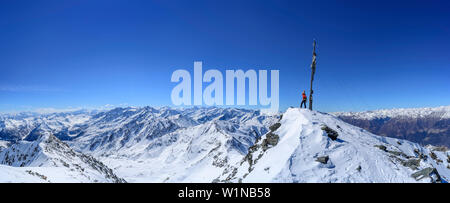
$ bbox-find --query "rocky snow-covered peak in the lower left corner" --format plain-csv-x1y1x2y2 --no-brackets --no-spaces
0,135,124,183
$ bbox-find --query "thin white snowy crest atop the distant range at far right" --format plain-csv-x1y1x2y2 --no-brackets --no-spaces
332,106,450,120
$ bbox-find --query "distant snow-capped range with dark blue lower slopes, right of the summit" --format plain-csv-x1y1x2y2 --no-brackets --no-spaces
333,106,450,147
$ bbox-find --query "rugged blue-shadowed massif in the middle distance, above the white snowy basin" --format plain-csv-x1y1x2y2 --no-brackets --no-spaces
71,107,272,155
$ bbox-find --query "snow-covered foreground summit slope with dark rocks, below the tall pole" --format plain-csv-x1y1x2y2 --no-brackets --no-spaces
216,108,450,183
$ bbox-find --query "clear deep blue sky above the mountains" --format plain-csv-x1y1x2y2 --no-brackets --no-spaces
0,0,450,112
